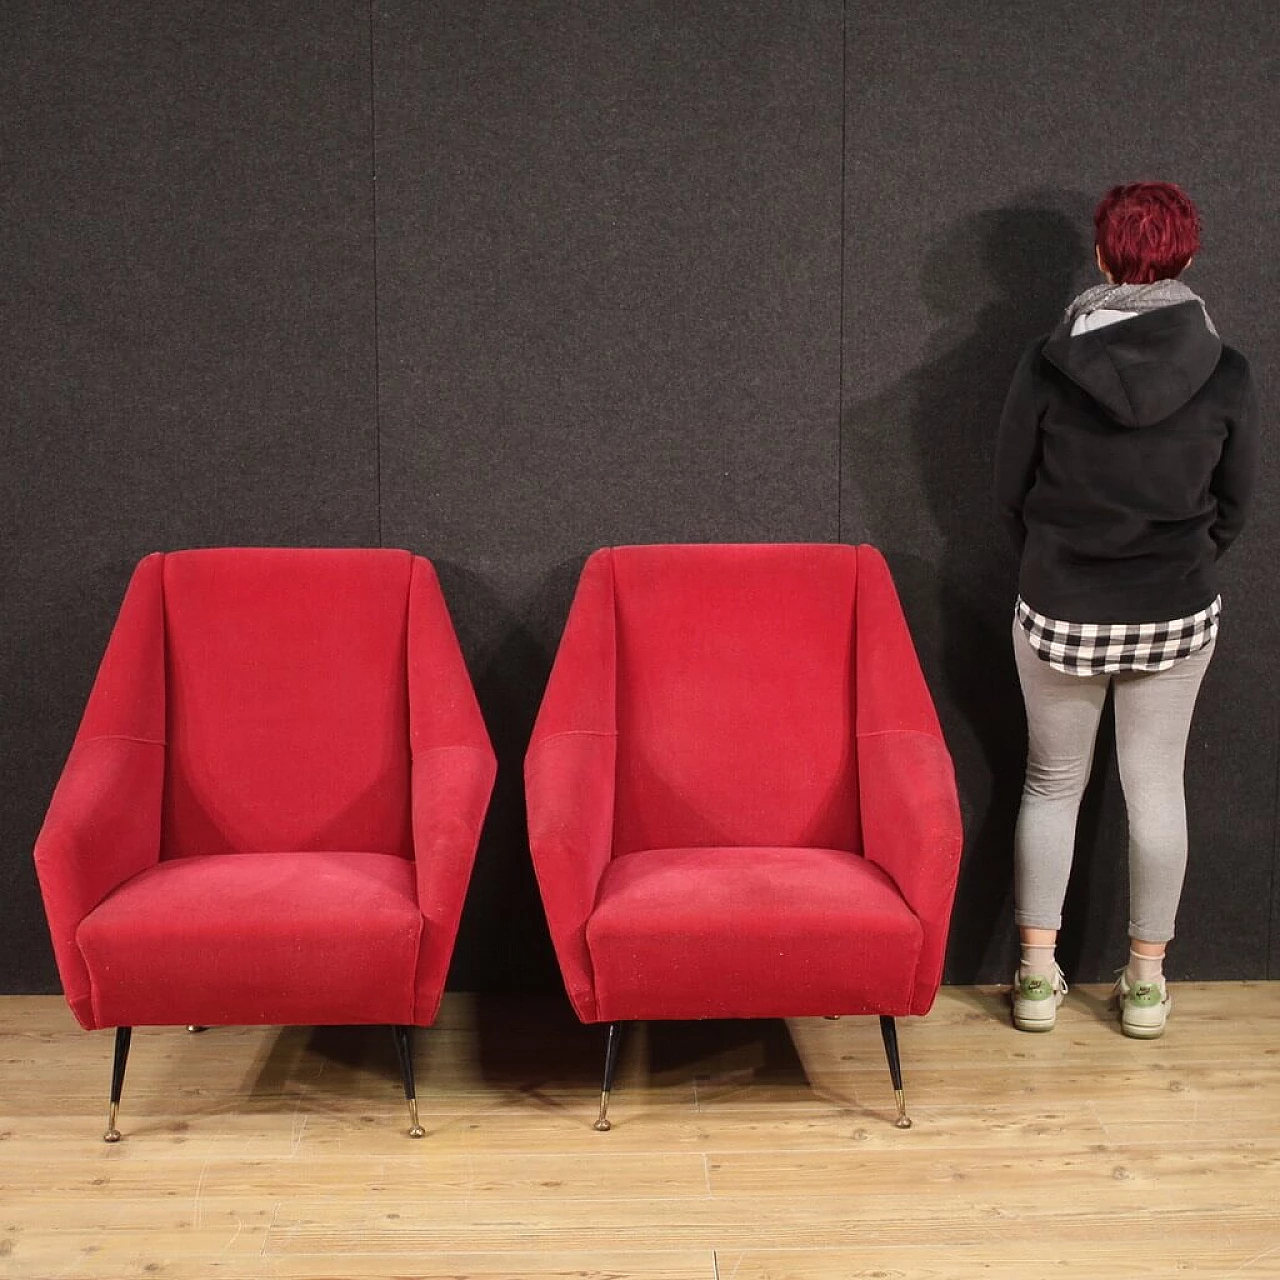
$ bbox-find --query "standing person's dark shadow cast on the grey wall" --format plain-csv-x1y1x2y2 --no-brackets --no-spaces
841,191,1092,983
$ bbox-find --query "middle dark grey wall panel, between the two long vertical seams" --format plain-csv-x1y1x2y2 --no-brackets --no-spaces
375,0,842,986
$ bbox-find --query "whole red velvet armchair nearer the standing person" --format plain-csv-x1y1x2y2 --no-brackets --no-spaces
525,545,961,1129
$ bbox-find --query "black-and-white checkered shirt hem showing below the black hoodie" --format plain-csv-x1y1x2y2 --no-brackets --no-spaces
1016,596,1222,676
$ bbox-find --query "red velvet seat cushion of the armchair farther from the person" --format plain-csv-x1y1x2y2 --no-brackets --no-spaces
76,852,424,1027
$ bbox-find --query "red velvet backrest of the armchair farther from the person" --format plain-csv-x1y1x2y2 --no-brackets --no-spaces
161,548,413,858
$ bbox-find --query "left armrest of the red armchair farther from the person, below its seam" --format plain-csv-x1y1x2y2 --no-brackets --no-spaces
36,737,165,1029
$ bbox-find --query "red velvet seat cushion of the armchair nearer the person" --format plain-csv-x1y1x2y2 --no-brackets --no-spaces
586,847,923,1021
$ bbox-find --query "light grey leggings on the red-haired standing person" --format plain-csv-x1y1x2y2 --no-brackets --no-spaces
1014,620,1213,942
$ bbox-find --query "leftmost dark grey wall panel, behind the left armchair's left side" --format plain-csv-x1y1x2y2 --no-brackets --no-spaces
0,0,378,991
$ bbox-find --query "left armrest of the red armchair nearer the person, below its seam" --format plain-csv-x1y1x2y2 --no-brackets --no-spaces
525,730,617,1023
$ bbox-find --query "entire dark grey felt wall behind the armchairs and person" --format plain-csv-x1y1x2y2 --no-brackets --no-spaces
0,0,1280,991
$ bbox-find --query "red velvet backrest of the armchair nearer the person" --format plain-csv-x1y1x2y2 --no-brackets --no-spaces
600,545,861,855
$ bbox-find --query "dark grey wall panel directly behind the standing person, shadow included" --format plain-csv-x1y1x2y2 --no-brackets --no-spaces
841,0,1280,982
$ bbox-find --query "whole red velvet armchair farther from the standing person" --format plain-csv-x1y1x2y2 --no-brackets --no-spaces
36,549,494,1142
